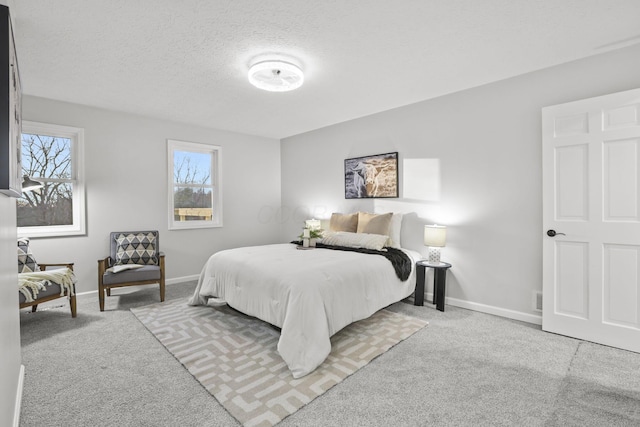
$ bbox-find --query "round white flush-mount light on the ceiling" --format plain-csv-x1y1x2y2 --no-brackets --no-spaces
249,60,304,92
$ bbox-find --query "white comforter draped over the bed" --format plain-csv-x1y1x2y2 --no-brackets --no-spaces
189,243,420,378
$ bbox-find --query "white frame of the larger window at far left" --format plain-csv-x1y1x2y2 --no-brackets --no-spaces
16,120,87,238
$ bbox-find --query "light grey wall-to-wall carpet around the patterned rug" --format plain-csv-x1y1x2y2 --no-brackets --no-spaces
20,282,640,427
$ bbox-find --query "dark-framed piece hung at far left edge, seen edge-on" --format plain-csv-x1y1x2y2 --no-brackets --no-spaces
0,5,22,197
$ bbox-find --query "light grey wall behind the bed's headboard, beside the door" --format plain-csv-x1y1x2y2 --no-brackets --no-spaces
281,45,640,322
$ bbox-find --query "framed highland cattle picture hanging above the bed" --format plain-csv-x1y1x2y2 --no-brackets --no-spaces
344,152,398,199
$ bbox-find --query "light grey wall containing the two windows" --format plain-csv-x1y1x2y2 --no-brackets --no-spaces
23,96,280,296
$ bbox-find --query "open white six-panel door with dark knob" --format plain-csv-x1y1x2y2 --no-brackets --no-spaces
542,89,640,352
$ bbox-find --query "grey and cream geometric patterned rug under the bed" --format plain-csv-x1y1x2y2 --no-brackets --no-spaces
131,299,428,426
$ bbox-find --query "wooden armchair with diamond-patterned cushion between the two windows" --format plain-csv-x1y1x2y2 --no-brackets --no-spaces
98,230,165,311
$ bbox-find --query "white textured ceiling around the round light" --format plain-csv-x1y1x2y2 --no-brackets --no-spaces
13,0,640,138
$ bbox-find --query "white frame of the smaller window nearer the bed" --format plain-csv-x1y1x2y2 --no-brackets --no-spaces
167,139,223,230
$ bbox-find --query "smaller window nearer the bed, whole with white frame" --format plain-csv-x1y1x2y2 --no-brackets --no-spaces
167,139,222,230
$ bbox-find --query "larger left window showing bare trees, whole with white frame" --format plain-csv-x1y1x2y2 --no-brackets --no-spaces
17,121,85,237
